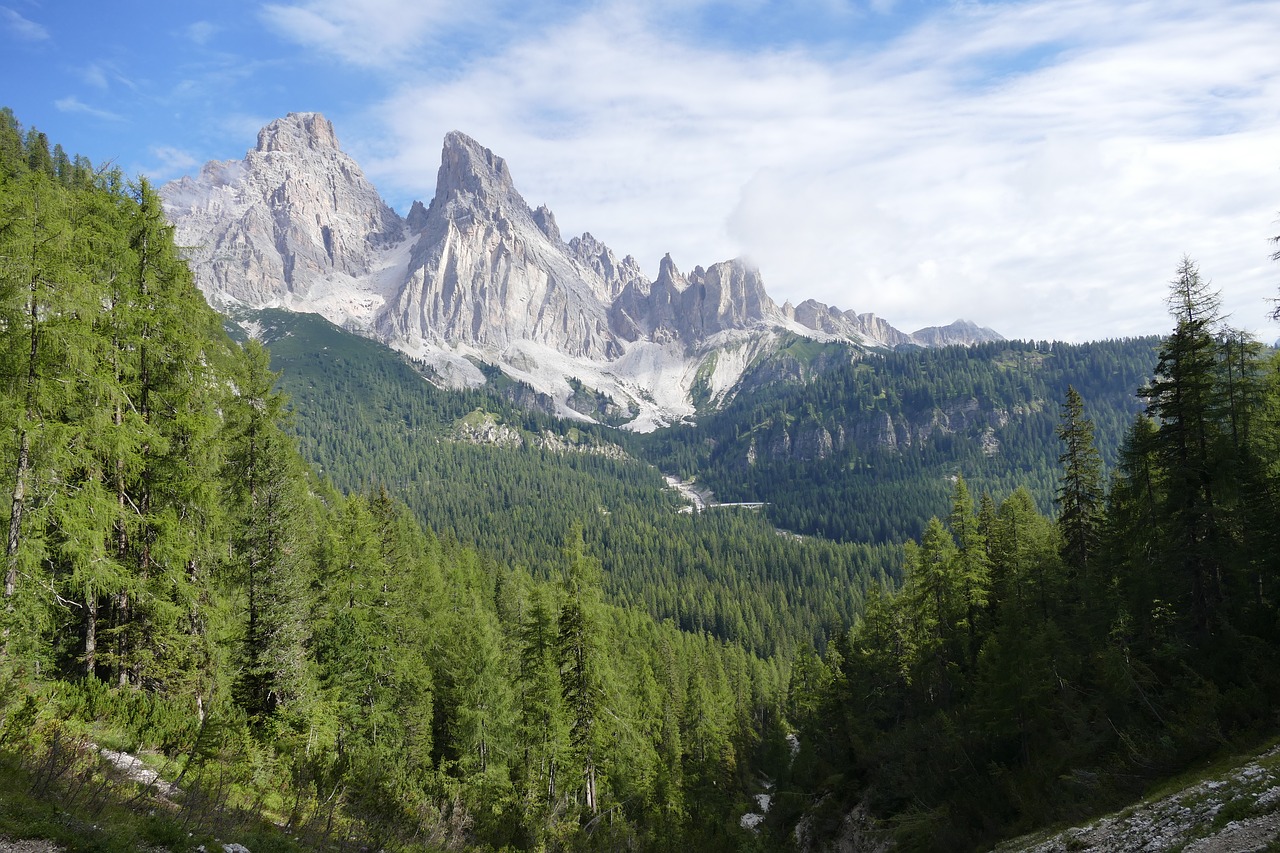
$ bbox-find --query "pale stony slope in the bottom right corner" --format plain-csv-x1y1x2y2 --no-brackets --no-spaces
996,747,1280,853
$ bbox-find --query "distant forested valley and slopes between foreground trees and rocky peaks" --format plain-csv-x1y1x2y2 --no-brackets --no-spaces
248,311,1158,653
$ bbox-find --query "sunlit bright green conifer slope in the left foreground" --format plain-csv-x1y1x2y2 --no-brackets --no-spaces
0,111,787,850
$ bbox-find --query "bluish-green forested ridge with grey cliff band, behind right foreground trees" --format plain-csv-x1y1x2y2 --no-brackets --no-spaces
639,338,1160,543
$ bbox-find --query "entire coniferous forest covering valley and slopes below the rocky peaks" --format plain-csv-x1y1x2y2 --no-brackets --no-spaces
0,110,1280,853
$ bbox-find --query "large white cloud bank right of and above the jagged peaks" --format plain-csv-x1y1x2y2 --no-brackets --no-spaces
344,0,1280,339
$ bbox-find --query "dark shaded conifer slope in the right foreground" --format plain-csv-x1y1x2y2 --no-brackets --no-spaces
780,260,1280,850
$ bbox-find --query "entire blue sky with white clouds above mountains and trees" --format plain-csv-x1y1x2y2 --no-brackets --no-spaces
0,0,1280,342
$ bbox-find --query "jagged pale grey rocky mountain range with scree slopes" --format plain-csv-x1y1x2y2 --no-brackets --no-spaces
161,113,1001,432
